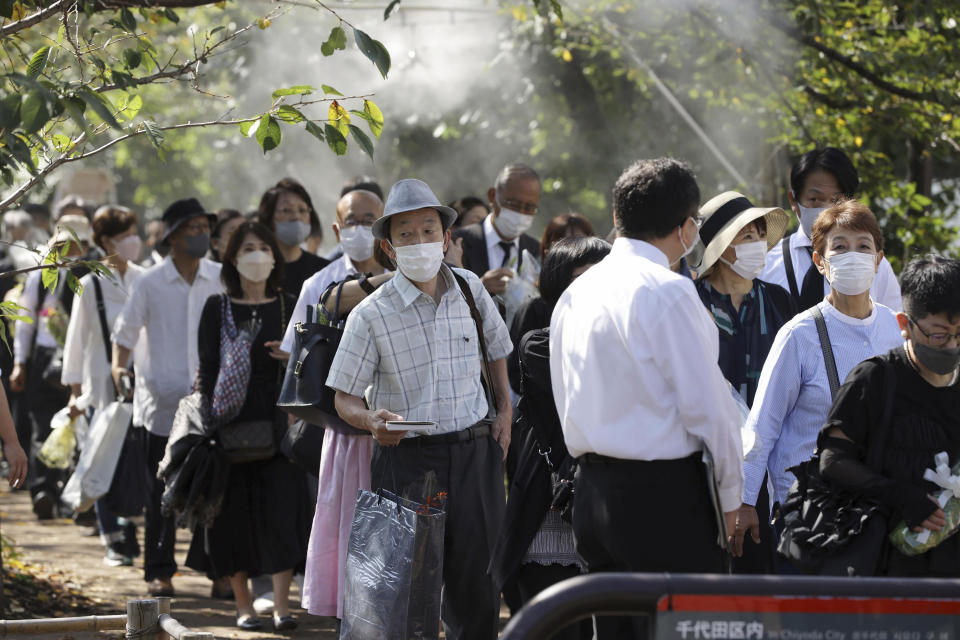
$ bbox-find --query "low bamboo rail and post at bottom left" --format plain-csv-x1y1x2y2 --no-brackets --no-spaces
0,598,214,640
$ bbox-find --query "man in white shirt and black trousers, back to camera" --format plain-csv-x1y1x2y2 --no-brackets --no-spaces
550,158,743,639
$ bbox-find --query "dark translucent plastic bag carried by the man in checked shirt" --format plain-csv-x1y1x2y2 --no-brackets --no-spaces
340,490,446,640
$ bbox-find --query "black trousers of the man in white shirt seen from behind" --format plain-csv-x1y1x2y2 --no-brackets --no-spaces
573,453,725,640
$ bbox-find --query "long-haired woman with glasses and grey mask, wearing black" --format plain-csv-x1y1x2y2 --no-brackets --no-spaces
257,178,330,299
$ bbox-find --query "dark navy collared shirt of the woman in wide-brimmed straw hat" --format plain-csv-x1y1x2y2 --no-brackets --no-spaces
694,278,789,406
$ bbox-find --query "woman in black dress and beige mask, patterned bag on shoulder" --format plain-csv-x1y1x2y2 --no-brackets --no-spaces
187,222,310,630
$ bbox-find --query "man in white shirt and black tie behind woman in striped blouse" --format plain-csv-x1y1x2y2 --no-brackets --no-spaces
760,147,901,313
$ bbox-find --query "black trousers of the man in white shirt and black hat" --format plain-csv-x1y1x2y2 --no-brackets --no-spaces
134,427,177,582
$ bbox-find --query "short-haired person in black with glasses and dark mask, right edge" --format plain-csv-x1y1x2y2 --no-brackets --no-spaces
819,256,960,577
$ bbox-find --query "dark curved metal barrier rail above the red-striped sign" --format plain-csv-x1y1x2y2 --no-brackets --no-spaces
501,573,960,640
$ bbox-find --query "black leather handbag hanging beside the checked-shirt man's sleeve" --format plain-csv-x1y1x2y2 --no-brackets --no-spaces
277,278,369,438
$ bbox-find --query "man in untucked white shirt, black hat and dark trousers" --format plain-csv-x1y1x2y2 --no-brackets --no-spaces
112,198,223,596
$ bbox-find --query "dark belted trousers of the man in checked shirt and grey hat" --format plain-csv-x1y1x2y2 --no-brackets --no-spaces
370,436,506,640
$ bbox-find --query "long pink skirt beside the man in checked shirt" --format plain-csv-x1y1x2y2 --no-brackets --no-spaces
301,431,373,618
